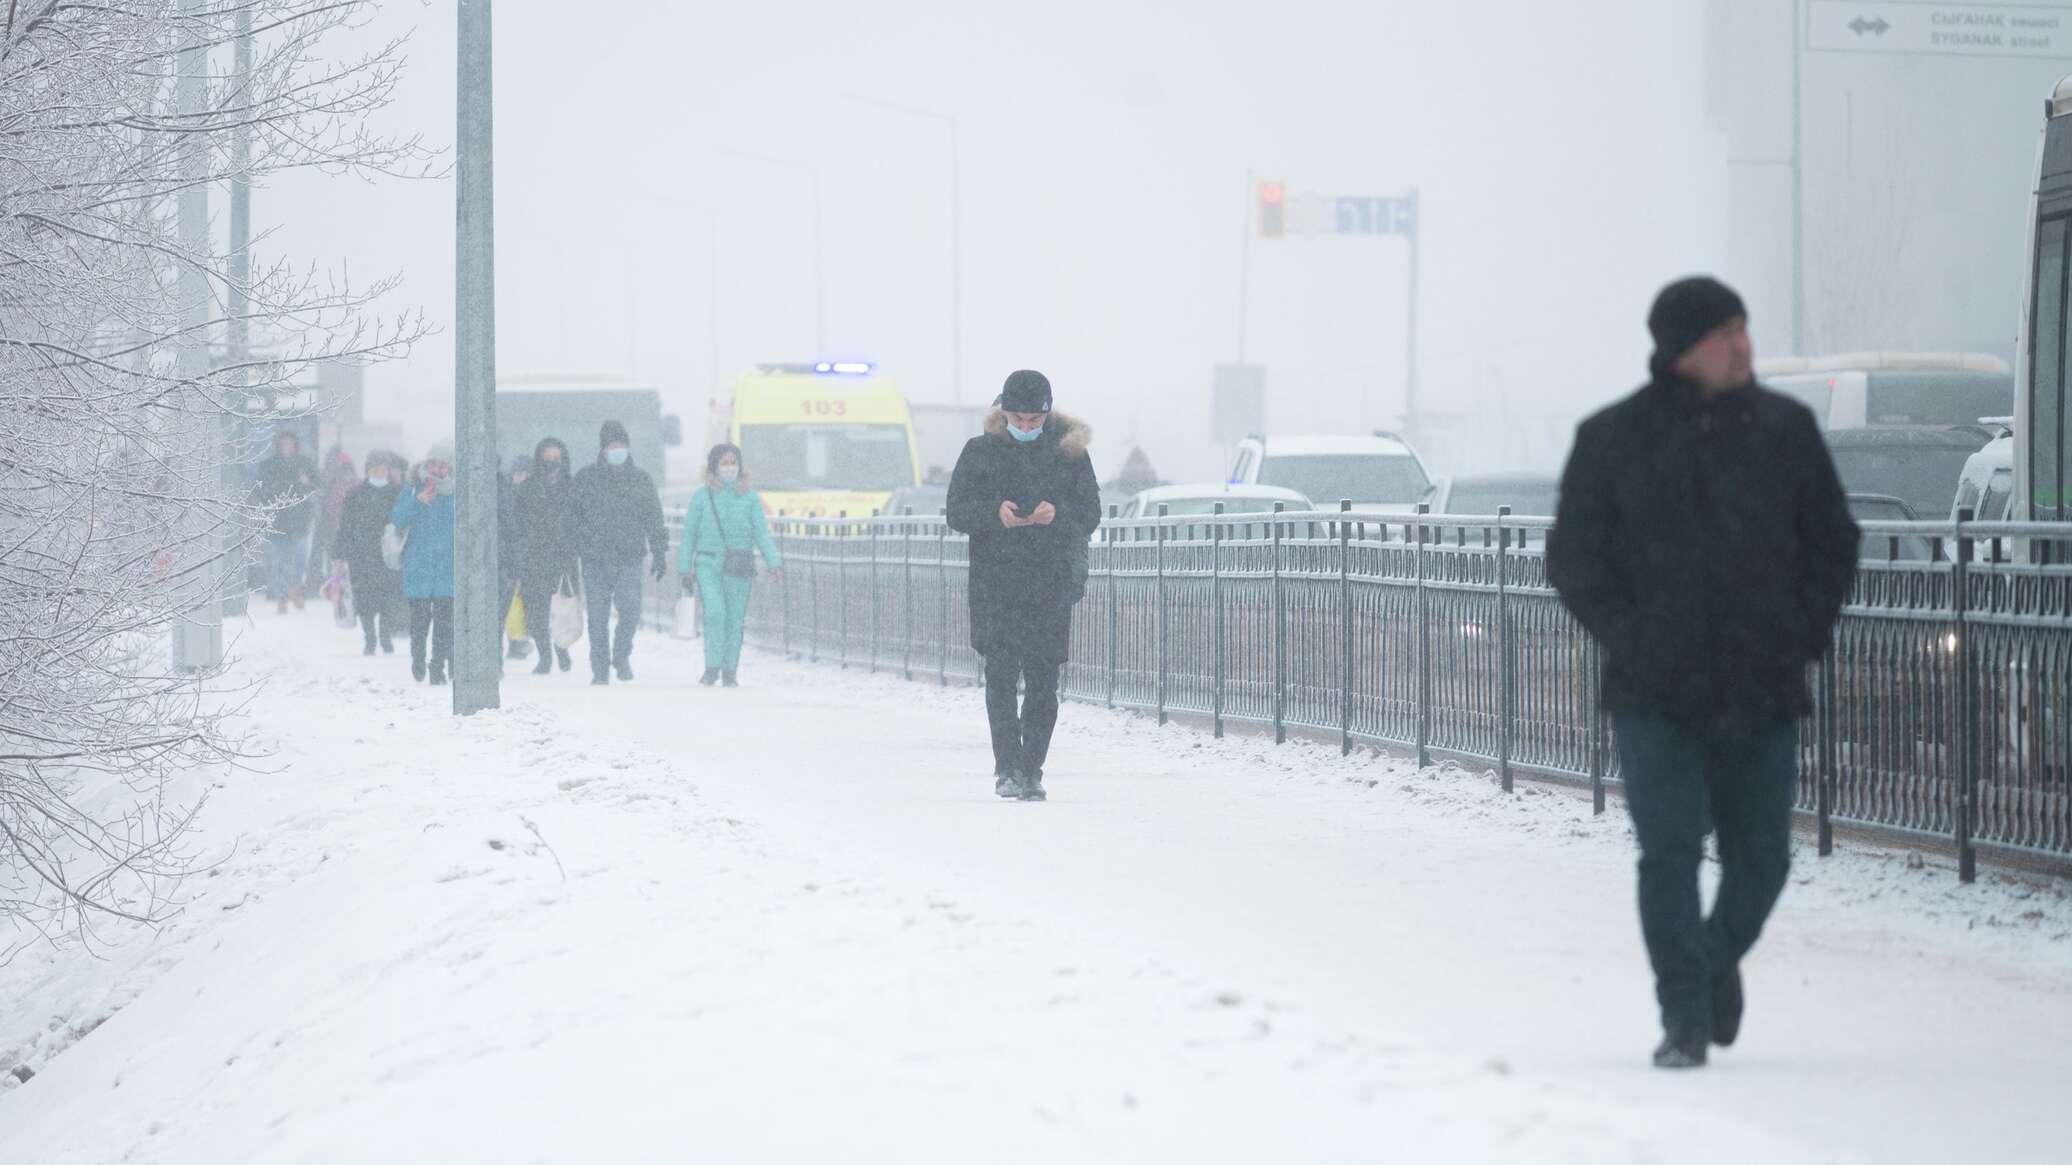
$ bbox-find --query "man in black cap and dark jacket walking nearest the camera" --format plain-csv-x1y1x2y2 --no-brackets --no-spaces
1548,278,1857,1068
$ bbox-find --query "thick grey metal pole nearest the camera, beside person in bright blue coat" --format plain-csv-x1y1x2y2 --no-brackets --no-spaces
454,0,506,715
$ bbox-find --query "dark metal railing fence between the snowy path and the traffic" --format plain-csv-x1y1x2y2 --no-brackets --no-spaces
655,510,2072,881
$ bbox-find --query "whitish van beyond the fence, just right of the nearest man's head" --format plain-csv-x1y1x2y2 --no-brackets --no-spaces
1755,352,2014,429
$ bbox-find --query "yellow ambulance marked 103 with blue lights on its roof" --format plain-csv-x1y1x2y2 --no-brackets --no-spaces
713,361,920,518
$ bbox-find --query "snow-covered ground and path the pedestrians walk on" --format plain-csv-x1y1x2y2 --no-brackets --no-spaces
0,609,2072,1165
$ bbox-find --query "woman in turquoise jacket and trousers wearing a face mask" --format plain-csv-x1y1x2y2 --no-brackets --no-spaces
675,444,783,688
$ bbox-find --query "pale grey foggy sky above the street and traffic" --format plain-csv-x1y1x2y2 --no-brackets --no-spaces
255,0,1728,477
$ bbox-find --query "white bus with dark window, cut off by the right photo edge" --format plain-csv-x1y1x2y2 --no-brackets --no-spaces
2008,77,2072,526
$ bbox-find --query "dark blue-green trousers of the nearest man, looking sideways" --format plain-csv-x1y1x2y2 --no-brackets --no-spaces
1616,713,1798,1026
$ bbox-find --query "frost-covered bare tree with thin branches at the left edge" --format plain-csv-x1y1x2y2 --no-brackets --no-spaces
0,0,427,935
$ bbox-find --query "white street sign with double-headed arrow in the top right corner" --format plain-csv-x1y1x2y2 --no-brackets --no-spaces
1807,0,2072,60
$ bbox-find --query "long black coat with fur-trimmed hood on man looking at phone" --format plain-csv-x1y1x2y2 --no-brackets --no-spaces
947,408,1100,663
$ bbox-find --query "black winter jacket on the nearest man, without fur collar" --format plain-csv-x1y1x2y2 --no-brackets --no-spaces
1546,375,1859,732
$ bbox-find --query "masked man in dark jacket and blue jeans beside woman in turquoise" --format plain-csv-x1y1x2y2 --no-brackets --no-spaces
576,421,669,684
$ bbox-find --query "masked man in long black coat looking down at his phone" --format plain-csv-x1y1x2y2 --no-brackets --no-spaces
949,371,1100,800
